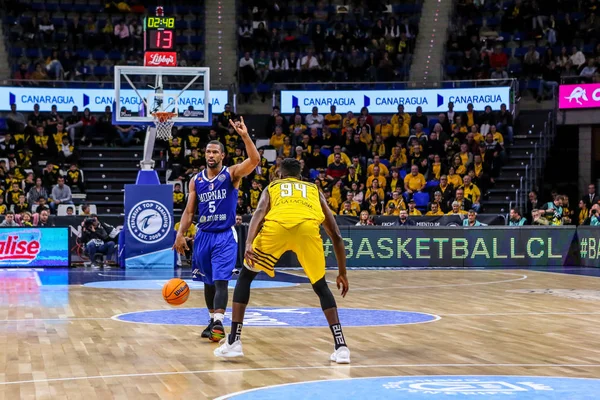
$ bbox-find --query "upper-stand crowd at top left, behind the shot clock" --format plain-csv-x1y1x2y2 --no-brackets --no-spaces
3,0,204,85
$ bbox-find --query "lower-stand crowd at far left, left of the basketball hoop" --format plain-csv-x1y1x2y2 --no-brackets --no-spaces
0,104,96,226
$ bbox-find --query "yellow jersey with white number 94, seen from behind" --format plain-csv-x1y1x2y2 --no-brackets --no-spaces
265,178,325,228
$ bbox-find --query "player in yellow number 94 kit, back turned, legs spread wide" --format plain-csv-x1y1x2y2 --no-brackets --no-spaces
214,158,350,364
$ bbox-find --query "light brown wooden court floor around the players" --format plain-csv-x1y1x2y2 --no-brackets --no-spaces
0,270,600,400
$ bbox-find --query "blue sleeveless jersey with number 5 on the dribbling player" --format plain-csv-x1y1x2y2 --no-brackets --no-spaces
194,167,238,232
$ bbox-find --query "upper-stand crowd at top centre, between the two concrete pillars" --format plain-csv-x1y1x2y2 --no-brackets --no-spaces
238,0,419,99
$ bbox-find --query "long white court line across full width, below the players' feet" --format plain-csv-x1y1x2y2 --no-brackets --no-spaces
0,360,600,386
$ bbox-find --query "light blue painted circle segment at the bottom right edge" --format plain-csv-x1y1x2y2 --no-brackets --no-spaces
217,375,600,400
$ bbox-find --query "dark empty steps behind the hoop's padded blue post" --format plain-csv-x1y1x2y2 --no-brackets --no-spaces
81,146,165,216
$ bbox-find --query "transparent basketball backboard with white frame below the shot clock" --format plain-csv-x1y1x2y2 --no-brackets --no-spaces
113,65,212,126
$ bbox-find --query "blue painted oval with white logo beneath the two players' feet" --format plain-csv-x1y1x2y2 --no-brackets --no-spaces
113,307,440,328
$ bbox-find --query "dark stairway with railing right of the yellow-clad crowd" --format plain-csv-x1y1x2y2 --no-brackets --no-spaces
483,110,549,214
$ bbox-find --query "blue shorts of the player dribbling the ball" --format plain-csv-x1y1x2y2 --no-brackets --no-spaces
192,227,238,285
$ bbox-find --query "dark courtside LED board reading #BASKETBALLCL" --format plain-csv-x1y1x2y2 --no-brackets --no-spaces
322,226,578,267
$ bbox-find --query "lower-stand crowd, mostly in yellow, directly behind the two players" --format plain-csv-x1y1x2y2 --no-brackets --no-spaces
168,103,512,222
